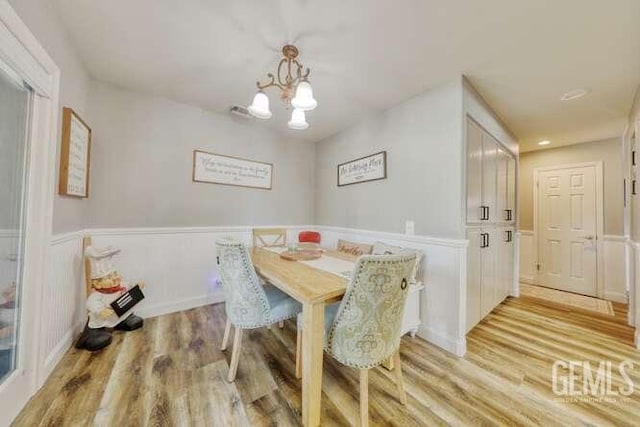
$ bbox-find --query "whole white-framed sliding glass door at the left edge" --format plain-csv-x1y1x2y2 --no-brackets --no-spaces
0,1,59,425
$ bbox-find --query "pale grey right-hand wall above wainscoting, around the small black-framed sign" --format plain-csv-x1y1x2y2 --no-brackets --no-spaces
315,80,463,238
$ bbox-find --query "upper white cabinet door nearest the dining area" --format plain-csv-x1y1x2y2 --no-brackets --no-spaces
467,119,482,224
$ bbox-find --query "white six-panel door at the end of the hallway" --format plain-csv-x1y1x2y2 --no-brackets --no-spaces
536,164,601,296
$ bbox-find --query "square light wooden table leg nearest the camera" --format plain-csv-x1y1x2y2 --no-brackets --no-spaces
302,303,324,427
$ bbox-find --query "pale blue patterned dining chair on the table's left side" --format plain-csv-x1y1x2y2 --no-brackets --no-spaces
216,240,302,382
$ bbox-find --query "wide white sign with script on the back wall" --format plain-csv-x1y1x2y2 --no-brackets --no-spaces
193,150,273,190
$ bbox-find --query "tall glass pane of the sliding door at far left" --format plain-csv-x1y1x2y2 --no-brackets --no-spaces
0,63,32,385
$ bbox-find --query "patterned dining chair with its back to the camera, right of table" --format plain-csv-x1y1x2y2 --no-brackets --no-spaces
296,252,417,426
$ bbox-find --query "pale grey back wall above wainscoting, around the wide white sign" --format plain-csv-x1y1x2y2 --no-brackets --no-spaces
87,82,315,228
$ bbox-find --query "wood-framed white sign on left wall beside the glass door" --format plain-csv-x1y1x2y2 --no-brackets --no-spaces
58,107,91,197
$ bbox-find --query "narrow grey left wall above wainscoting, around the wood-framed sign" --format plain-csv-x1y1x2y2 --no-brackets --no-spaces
9,0,92,233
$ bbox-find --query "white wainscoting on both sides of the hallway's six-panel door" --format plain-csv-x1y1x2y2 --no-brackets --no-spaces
519,230,627,303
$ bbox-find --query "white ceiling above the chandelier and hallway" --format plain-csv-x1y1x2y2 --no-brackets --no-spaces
55,0,640,151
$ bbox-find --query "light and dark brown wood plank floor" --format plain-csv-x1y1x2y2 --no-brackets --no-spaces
14,297,640,426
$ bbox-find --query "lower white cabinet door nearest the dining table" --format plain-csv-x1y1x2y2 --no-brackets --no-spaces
467,228,483,332
